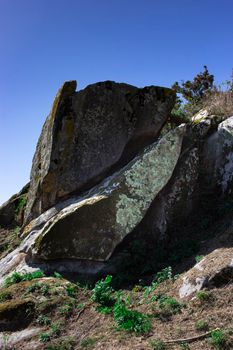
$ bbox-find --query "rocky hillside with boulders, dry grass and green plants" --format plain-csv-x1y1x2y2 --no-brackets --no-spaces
0,81,233,350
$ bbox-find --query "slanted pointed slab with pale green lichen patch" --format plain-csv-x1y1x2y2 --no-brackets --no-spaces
31,125,186,261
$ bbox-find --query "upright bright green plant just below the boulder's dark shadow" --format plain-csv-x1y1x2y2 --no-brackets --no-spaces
91,275,115,306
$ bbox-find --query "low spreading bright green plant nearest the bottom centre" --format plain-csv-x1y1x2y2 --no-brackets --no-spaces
114,298,152,334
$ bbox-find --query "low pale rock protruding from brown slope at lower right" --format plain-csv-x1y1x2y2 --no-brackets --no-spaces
179,248,233,298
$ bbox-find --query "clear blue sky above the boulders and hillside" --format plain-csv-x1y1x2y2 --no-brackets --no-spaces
0,0,233,203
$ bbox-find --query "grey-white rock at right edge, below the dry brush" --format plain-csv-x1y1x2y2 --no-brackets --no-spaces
203,117,233,195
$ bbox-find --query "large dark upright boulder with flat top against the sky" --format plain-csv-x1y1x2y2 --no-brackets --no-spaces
25,81,175,223
